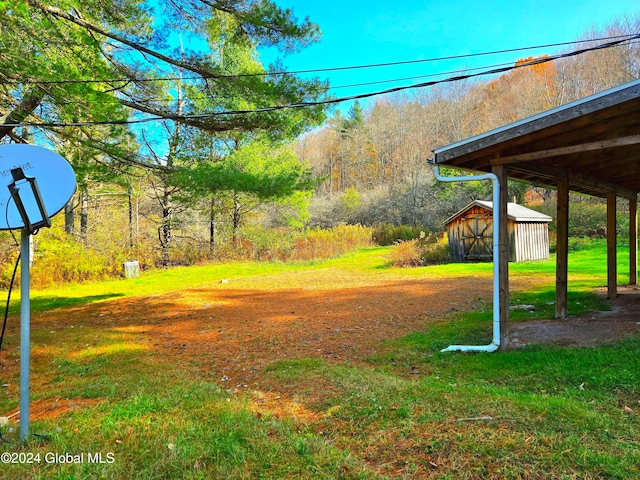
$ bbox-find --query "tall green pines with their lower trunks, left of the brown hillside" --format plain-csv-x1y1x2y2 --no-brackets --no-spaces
0,0,327,265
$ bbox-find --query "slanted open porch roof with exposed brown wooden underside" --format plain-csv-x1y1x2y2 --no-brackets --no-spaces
434,80,640,199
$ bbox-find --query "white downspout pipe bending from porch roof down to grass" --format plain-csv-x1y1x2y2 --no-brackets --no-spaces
429,159,500,352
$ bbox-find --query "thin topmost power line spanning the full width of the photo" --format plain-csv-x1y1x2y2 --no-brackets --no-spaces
0,34,637,88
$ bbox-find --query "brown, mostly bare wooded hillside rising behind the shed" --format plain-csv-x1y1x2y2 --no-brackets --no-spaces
296,15,640,228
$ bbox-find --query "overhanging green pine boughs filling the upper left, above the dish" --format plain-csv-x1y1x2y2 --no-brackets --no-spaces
0,0,326,163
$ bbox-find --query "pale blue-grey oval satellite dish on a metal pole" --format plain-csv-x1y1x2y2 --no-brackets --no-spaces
0,144,76,230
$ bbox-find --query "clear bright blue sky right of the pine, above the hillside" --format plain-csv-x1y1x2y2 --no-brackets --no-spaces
265,0,640,110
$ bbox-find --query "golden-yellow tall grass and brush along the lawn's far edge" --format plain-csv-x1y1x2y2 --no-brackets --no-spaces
0,224,372,288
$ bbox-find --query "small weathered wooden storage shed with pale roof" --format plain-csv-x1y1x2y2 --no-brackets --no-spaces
445,200,552,262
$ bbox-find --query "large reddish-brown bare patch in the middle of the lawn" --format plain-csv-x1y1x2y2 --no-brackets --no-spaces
76,278,491,388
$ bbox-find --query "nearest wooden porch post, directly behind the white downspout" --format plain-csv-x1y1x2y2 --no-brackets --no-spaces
493,165,509,350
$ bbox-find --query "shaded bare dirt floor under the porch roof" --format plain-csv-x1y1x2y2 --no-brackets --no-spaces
510,285,640,347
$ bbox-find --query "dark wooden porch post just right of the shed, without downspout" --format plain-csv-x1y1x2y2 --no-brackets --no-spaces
556,179,569,318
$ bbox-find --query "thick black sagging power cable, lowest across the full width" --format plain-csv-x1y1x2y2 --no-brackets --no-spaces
4,33,640,128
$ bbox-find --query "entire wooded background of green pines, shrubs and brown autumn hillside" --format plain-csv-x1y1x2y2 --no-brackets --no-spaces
0,0,640,284
